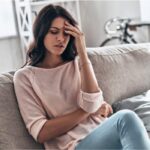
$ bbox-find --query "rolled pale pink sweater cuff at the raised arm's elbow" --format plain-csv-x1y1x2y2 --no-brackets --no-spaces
78,90,103,113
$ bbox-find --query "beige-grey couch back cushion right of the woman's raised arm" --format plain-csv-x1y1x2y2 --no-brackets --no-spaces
88,44,150,104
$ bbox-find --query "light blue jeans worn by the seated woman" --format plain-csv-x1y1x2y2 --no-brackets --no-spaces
76,110,150,150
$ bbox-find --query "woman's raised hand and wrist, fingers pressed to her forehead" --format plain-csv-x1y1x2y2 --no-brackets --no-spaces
65,21,86,54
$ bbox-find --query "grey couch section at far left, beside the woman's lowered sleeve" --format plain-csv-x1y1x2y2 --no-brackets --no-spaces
0,74,43,150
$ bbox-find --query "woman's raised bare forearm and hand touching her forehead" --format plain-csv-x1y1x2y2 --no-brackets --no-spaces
65,22,100,93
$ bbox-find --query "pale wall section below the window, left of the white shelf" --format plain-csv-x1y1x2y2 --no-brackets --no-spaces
0,37,23,73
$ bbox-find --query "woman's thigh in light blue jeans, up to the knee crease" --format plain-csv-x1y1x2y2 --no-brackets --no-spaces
76,111,122,150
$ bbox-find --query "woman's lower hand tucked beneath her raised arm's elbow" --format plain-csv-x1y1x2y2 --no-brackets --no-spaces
92,101,113,118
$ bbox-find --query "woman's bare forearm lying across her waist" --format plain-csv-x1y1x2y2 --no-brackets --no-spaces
38,108,89,143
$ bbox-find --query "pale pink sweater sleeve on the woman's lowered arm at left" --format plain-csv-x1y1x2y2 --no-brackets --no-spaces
14,70,47,141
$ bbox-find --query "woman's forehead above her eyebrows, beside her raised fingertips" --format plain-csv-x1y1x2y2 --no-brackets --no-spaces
51,17,67,28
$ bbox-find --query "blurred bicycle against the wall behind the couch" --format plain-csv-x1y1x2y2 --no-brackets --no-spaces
100,17,150,47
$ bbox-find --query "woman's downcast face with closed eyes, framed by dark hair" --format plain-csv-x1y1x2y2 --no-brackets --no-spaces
44,17,70,55
